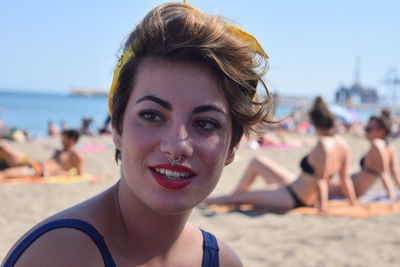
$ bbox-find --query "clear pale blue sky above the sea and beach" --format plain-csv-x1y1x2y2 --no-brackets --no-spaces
0,0,400,99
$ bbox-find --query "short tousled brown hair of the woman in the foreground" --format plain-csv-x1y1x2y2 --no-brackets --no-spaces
112,3,272,159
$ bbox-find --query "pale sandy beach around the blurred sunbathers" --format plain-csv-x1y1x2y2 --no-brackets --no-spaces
0,135,400,267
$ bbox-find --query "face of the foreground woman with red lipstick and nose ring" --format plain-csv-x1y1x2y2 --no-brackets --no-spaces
114,60,234,213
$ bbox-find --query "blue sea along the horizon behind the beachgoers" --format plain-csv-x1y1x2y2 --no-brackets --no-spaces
0,91,371,137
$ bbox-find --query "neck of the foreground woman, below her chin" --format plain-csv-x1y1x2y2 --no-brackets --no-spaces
114,178,191,263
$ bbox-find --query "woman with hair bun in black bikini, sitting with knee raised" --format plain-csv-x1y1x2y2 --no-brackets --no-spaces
205,97,356,211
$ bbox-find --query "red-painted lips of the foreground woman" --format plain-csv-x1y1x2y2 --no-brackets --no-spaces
150,164,196,190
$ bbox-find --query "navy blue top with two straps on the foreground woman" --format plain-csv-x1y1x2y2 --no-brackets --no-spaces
4,219,219,267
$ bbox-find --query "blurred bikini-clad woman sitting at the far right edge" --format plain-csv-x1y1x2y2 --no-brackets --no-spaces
329,110,400,203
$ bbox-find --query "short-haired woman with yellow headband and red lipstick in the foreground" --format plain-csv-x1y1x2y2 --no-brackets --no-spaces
5,3,270,266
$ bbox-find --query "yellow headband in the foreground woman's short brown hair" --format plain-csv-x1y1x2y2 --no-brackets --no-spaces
108,4,268,115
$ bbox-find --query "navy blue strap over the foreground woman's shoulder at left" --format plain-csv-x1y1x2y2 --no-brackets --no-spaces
4,219,116,267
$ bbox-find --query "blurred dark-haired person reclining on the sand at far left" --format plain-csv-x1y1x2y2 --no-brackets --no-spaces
0,130,83,181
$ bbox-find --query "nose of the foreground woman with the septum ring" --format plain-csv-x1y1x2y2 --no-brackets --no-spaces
160,124,193,161
